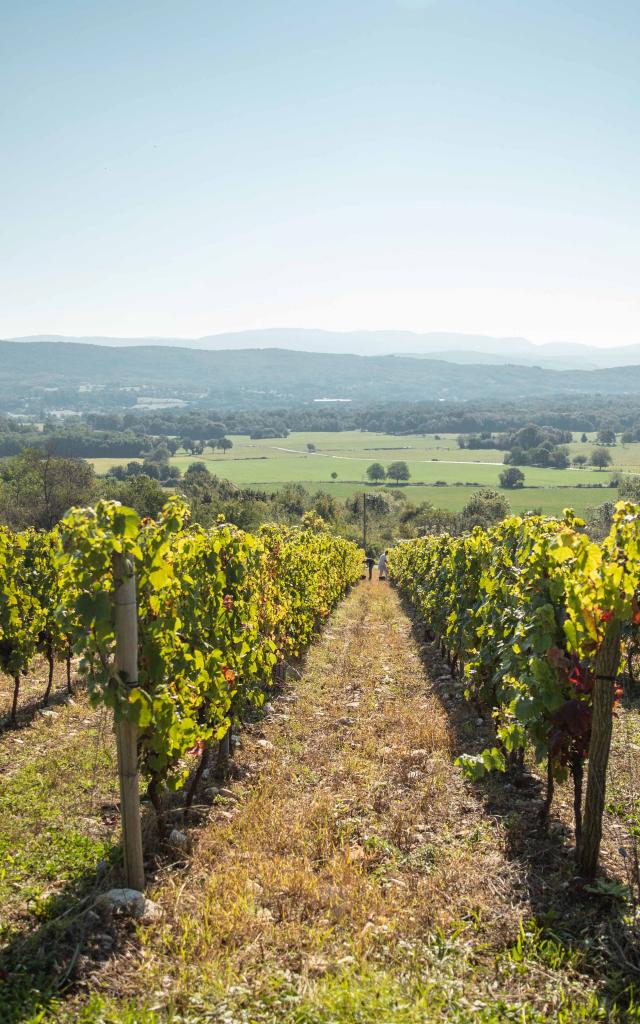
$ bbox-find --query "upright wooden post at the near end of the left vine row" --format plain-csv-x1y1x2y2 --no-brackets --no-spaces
113,555,144,890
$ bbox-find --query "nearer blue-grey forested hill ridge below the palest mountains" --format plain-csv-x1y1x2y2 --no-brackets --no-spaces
0,341,640,409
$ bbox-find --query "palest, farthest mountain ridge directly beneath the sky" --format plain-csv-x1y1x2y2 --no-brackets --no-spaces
8,328,640,370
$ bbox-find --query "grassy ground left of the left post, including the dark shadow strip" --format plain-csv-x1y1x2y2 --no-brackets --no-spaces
0,679,122,1024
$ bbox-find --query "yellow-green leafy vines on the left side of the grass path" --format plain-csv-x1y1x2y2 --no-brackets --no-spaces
0,499,362,880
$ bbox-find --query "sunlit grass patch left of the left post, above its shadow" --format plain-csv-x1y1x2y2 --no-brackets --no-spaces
0,696,118,942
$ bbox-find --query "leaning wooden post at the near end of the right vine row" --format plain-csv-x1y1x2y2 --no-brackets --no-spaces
578,623,621,879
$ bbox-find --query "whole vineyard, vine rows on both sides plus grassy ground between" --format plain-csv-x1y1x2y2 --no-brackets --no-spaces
0,499,640,1024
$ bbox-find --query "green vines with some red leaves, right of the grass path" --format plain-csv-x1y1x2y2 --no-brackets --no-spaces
390,503,640,878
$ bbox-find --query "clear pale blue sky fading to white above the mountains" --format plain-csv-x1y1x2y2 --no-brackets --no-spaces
0,0,640,345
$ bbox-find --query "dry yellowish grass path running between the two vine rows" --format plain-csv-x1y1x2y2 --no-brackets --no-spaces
10,582,640,1024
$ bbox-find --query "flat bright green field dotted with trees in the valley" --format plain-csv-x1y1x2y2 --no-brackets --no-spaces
92,431,640,512
